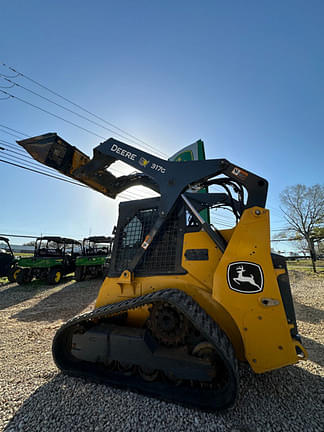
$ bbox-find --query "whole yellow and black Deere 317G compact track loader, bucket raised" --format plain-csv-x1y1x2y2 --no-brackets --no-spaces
19,133,307,410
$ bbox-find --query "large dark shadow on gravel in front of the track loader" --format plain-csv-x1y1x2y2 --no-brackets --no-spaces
4,365,323,432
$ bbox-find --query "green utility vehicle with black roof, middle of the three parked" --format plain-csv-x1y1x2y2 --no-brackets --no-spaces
16,236,81,285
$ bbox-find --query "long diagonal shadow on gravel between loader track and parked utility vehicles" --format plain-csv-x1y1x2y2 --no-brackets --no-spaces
12,280,102,322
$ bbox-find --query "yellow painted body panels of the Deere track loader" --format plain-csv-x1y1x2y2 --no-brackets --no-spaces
96,207,307,373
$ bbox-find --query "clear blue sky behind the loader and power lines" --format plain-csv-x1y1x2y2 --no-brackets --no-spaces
0,0,324,250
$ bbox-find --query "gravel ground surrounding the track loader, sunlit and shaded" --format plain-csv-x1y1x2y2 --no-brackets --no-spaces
0,271,324,432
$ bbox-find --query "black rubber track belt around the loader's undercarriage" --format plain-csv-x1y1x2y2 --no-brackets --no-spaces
53,289,238,411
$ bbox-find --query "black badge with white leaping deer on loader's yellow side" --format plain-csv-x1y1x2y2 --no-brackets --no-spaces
227,261,264,294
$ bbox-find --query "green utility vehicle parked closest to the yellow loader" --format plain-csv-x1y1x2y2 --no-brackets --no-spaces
75,236,114,281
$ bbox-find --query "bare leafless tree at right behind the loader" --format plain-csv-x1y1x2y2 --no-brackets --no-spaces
280,184,324,273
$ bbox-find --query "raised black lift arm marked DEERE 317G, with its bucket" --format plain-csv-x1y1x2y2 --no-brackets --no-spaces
17,133,268,215
